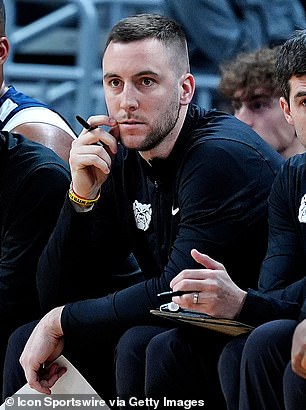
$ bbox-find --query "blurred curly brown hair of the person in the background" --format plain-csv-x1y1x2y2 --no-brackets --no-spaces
219,46,281,100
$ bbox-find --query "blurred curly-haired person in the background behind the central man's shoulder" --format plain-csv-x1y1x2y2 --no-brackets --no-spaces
219,46,305,158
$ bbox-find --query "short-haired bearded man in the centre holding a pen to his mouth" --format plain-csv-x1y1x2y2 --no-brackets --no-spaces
4,14,283,409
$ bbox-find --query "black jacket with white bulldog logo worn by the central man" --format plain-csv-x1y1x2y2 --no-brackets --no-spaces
38,106,283,337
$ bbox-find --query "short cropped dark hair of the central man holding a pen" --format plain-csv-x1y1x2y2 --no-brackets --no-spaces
105,14,189,71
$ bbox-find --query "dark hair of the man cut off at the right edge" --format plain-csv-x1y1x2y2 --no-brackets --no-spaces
276,30,306,102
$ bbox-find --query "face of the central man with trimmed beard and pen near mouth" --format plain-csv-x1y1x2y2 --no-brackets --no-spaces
103,39,181,151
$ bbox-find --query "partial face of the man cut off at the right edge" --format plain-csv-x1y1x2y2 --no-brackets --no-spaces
281,75,306,147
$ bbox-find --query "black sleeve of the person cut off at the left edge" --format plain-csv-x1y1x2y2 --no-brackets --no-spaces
0,164,70,327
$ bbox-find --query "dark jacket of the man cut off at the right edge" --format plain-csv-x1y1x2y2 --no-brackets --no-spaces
240,154,306,325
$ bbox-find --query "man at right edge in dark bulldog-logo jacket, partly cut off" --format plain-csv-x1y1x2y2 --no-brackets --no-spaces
219,30,306,410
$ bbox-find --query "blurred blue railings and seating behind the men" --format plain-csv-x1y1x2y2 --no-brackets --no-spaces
4,0,306,133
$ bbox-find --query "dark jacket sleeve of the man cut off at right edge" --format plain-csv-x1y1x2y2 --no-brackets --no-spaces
259,160,306,304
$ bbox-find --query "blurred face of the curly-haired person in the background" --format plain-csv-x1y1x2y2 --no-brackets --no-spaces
233,88,295,153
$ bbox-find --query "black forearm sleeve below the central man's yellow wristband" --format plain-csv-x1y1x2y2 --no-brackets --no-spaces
37,167,138,313
